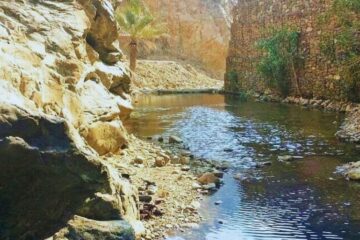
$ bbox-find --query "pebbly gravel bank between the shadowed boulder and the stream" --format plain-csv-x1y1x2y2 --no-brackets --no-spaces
119,136,228,240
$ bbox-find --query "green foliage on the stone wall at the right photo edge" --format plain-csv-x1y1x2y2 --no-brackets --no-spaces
320,0,360,101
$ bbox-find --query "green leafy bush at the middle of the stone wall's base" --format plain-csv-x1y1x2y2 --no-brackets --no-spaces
256,28,302,96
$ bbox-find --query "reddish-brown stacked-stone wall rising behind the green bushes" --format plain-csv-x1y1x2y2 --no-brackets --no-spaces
225,0,343,100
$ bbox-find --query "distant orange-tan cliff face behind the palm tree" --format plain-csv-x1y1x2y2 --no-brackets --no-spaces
119,0,235,79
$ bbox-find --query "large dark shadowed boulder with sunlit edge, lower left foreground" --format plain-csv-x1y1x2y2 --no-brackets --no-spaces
0,103,139,239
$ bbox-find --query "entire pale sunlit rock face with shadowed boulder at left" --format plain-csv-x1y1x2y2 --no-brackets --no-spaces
0,0,139,240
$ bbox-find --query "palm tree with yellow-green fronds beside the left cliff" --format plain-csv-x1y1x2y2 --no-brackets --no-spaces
116,0,165,71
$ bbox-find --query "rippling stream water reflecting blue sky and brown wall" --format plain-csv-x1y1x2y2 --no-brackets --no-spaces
127,95,360,240
